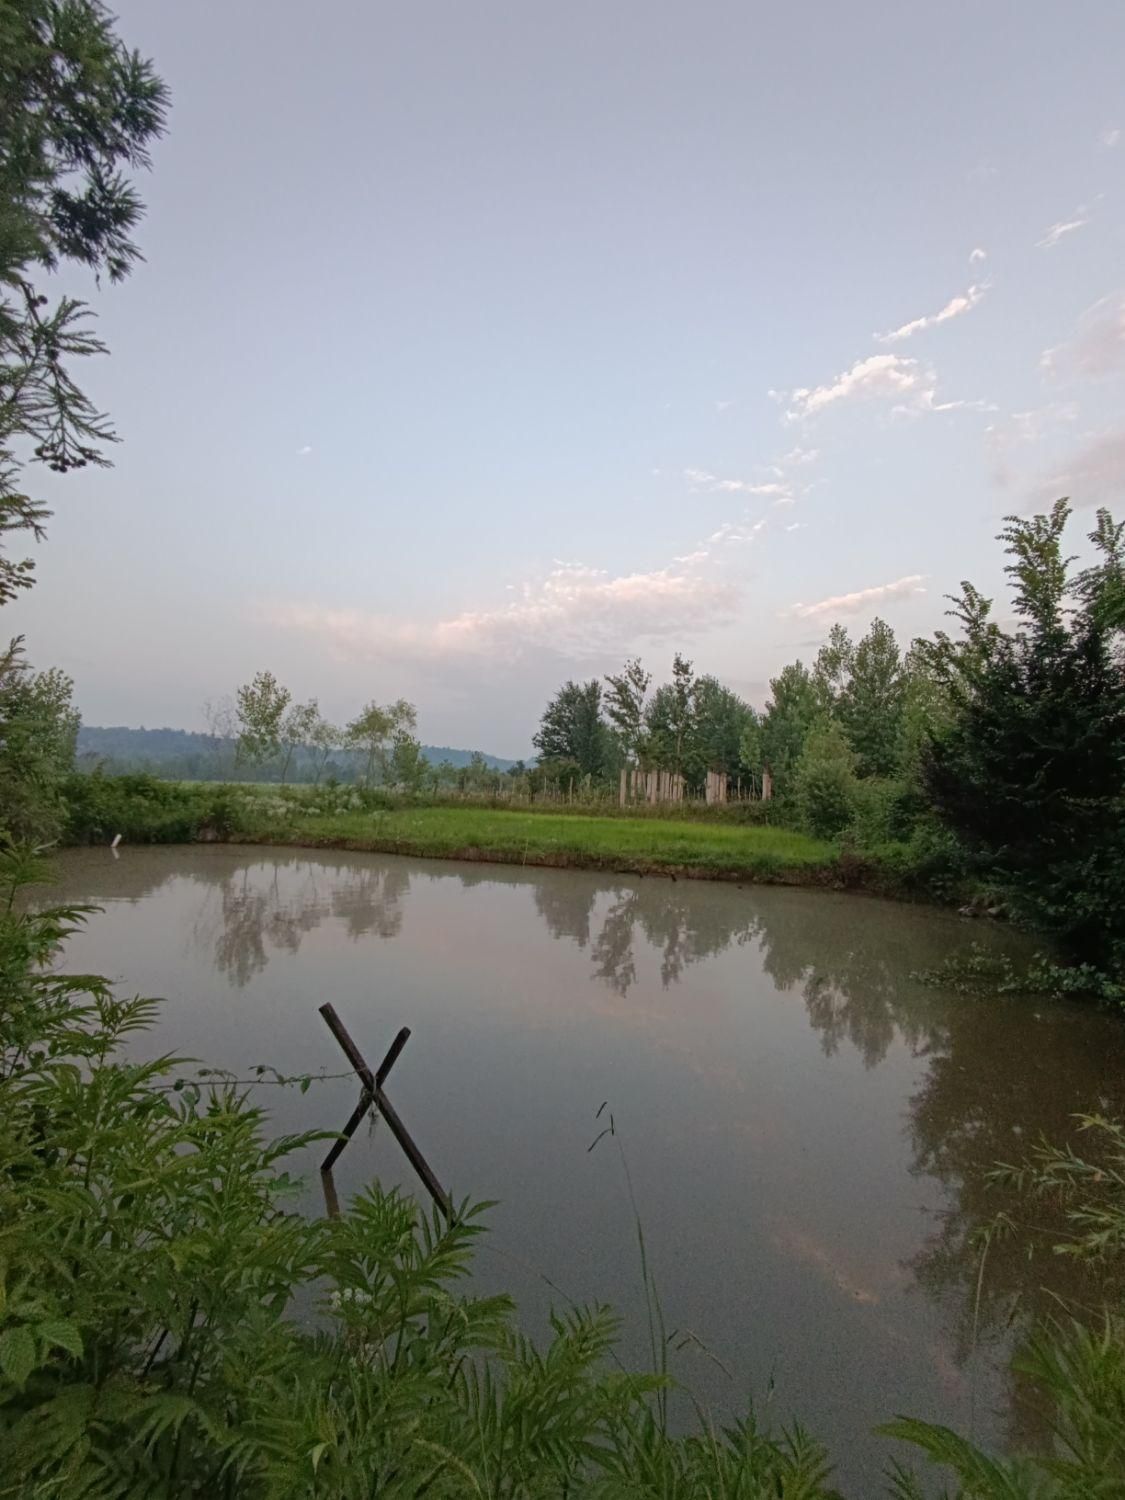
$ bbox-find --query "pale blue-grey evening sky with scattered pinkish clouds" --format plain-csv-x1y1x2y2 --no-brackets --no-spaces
8,0,1125,756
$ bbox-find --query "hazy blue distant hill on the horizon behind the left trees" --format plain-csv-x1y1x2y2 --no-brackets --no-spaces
78,725,516,782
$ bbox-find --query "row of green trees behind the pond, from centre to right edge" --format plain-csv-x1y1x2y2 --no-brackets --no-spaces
536,500,1125,978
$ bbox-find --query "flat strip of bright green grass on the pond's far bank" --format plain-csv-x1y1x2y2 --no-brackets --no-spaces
243,804,837,881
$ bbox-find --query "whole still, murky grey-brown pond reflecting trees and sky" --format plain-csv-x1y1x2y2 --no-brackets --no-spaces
51,846,1125,1496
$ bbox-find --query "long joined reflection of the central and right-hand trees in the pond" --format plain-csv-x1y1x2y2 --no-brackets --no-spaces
536,881,1125,1446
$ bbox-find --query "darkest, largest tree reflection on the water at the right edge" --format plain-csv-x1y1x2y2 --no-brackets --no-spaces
909,996,1125,1443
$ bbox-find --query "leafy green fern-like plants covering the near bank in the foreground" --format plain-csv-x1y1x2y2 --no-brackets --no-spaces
0,854,1125,1500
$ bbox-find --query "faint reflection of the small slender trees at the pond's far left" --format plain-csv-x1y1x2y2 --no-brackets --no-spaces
195,860,410,989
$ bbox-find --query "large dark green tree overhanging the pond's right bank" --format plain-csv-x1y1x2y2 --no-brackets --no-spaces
920,500,1125,974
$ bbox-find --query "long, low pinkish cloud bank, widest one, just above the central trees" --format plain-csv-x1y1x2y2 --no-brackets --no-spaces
260,561,738,665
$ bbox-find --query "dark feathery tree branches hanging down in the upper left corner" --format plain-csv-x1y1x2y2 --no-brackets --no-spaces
0,0,168,603
